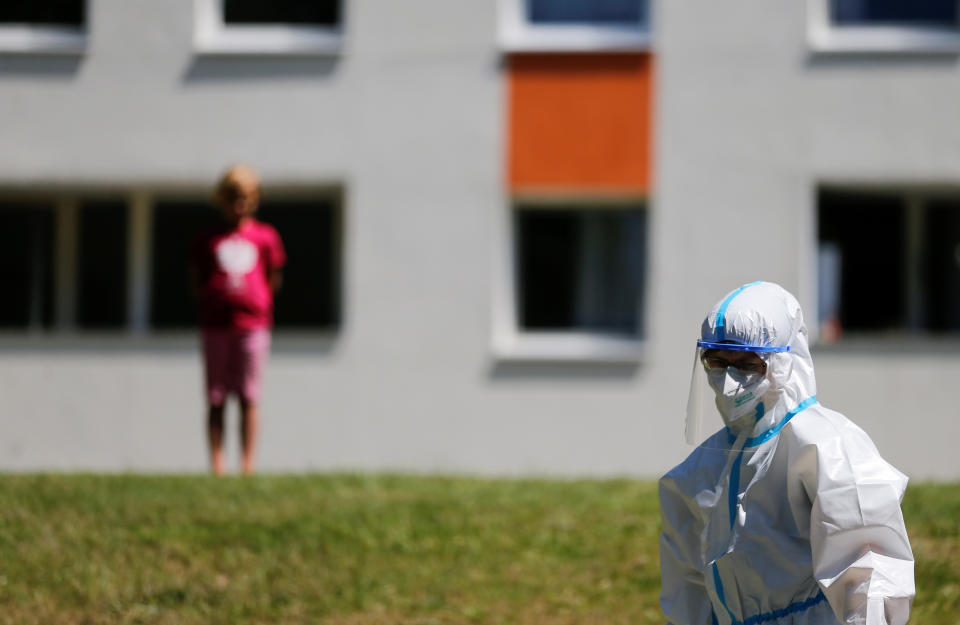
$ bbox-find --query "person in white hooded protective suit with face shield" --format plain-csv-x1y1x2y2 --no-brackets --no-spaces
660,282,914,625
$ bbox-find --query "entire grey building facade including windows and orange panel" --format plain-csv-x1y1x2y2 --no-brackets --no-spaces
0,0,960,479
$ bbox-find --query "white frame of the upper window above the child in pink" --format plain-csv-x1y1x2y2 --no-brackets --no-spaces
194,0,343,56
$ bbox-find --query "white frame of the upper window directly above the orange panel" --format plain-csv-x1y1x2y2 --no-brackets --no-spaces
498,0,652,52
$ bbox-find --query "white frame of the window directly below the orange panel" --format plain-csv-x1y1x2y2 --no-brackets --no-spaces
491,193,650,365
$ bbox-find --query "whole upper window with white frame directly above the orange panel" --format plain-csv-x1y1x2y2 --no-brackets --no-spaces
500,0,649,52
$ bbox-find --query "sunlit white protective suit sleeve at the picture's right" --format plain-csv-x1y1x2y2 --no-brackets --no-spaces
801,426,915,625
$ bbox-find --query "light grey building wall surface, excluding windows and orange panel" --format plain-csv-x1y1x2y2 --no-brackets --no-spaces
0,0,960,478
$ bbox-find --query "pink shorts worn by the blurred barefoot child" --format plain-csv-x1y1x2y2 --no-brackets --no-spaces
203,328,270,406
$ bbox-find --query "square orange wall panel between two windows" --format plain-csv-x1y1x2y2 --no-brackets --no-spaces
507,53,653,194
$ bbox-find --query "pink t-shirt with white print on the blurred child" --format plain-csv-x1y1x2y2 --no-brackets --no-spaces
190,219,287,330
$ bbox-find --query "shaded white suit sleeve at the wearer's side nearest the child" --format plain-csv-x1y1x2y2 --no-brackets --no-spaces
660,476,713,625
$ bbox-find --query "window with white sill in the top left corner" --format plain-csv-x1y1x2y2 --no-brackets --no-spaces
0,0,87,54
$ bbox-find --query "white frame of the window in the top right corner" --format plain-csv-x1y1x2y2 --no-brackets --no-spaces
807,0,960,54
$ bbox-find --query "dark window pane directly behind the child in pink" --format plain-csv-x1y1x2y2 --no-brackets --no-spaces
150,193,340,329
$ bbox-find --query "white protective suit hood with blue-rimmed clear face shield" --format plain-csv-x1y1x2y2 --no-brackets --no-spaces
685,282,817,446
